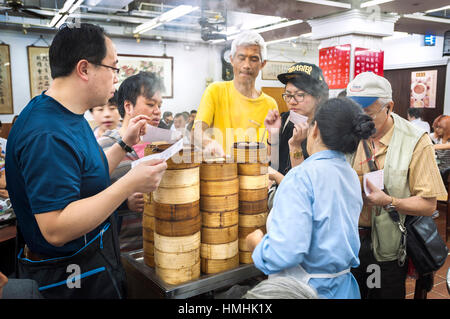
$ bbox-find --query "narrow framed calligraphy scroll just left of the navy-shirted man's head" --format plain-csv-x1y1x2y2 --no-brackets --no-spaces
27,46,52,98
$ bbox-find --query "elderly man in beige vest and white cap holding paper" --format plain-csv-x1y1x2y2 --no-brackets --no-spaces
347,72,446,299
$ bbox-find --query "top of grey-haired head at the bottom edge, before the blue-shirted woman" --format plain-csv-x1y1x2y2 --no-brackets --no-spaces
242,276,319,299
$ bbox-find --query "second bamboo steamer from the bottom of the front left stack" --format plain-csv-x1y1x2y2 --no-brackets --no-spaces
155,248,200,269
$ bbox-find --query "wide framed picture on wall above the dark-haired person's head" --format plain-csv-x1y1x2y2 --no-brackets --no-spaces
117,54,173,98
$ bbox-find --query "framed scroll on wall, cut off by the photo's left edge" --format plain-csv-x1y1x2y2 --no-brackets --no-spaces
0,44,14,114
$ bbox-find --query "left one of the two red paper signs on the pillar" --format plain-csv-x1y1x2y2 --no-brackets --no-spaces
319,44,351,89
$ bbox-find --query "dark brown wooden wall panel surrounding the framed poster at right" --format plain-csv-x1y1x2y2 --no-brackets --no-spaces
384,65,447,127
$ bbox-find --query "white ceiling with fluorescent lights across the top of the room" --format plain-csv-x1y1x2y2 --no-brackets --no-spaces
0,0,450,44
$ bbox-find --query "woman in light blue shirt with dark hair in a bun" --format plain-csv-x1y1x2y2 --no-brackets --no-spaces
247,99,374,298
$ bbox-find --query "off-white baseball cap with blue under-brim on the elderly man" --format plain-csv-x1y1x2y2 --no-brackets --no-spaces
347,72,392,108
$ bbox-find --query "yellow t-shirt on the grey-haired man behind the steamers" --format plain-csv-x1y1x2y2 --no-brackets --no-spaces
195,81,278,154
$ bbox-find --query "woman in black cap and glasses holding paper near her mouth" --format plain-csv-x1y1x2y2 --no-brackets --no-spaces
264,62,328,208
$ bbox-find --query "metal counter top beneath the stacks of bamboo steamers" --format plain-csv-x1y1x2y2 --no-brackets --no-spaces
121,249,264,299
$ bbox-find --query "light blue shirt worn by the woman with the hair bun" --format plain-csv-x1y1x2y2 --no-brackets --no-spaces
252,150,363,299
